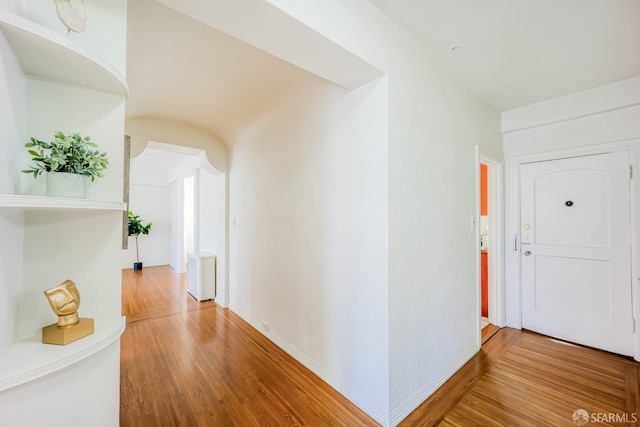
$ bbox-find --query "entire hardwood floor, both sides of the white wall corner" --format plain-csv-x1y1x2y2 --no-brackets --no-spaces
120,267,640,427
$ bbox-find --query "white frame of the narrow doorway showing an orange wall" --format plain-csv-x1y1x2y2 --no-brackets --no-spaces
474,145,506,342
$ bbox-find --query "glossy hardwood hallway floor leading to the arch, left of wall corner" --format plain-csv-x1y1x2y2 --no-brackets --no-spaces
120,267,377,427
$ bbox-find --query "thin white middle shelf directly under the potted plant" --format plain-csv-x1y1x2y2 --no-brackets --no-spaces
0,194,127,211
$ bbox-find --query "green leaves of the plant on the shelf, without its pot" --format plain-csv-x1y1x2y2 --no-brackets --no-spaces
22,131,109,181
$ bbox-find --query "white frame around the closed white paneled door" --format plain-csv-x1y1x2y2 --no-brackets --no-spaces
504,138,640,361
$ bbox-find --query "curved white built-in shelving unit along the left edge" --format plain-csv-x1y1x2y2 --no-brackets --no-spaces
0,0,129,427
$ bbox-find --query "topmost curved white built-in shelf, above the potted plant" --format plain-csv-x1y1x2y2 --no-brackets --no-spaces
0,10,129,96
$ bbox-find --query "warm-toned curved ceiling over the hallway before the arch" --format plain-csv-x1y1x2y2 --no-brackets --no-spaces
126,0,318,141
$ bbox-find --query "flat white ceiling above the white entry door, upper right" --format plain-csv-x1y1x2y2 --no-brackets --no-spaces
369,0,640,111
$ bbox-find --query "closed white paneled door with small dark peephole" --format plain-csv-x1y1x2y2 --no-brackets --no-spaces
520,151,634,356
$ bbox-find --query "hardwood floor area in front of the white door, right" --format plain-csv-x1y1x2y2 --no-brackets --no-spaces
400,328,640,427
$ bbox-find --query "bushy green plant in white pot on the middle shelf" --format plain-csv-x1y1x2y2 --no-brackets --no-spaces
22,131,109,198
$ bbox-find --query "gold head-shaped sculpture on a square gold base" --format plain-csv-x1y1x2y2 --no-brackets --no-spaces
42,280,93,345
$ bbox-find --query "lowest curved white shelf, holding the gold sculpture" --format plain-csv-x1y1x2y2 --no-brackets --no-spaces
0,317,126,391
